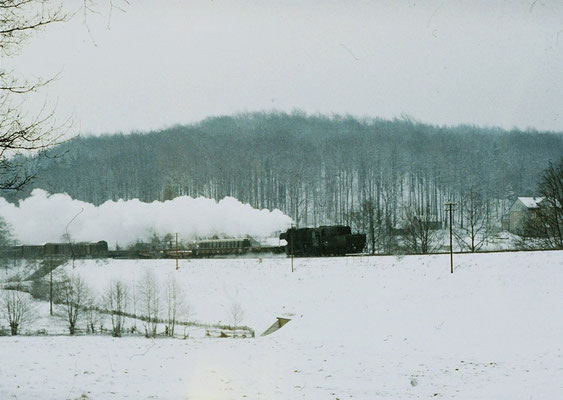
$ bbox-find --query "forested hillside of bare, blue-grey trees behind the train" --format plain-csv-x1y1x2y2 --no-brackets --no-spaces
3,113,563,230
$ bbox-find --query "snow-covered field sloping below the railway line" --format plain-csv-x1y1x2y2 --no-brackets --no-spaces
0,251,563,400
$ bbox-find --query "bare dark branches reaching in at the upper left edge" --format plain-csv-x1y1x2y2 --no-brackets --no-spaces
0,0,127,190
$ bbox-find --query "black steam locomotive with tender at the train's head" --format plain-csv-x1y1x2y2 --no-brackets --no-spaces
280,225,366,257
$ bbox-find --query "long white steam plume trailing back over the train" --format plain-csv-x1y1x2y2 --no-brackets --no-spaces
0,189,291,247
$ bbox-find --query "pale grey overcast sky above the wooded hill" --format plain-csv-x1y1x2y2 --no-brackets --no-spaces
3,0,563,134
